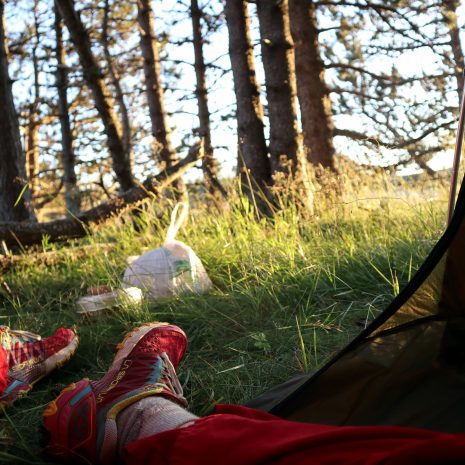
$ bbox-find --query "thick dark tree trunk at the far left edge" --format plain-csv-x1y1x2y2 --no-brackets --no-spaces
0,0,33,221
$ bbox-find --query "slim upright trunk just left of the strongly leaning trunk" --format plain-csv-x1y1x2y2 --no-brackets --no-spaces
54,2,81,214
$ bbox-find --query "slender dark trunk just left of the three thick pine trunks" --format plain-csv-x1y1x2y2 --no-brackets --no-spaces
191,0,225,200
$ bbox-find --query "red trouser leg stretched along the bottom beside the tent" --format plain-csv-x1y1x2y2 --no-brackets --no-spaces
124,406,465,465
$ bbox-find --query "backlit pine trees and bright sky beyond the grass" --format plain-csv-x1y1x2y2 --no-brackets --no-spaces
0,0,463,229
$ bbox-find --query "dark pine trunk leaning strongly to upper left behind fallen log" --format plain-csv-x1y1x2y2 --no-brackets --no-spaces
57,0,134,191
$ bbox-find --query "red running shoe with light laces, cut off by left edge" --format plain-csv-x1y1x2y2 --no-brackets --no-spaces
0,326,79,407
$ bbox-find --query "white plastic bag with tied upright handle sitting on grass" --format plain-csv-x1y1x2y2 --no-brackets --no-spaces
123,203,212,300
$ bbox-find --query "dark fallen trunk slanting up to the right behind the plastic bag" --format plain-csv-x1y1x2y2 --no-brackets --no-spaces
0,150,198,246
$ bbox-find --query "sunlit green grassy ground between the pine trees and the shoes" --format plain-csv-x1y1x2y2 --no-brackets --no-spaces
0,172,447,464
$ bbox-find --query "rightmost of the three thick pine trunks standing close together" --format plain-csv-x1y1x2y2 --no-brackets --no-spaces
289,0,335,171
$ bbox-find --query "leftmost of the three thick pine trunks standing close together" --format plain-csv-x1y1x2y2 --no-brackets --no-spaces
225,0,271,192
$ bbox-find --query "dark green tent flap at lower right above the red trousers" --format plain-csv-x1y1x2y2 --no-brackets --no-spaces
247,178,465,432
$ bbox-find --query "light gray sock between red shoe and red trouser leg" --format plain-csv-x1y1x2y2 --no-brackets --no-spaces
116,396,199,455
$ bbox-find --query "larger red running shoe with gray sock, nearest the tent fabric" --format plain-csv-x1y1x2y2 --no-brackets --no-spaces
43,323,187,464
